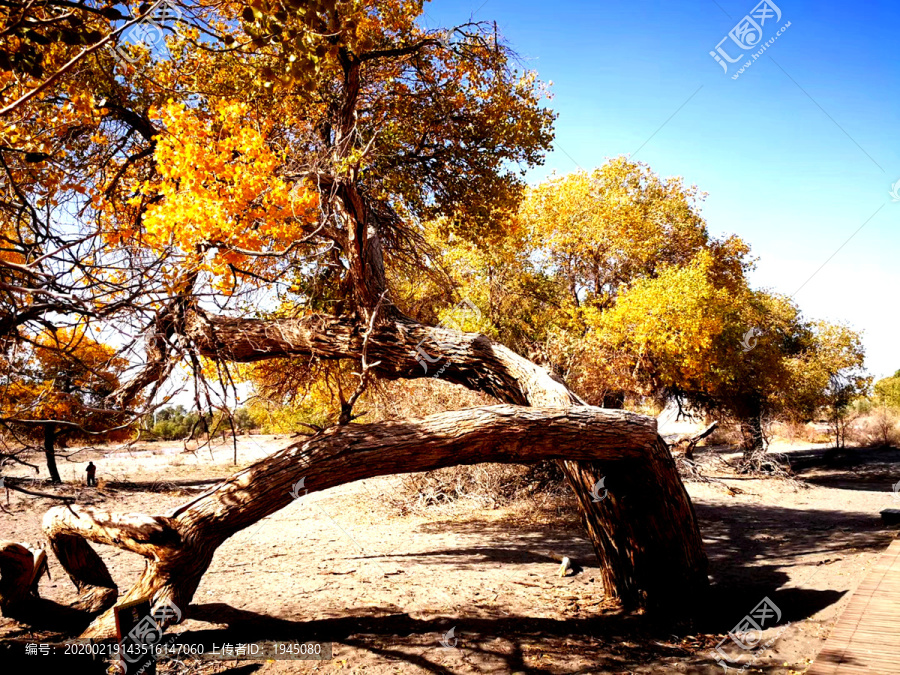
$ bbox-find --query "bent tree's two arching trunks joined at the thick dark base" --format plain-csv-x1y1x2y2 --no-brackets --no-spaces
75,309,708,635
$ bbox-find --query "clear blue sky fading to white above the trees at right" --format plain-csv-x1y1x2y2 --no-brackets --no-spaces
424,0,900,377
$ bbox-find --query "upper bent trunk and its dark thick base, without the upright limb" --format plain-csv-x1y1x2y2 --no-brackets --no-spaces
107,307,708,612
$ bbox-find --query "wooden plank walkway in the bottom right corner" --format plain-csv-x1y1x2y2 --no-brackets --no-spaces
806,539,900,675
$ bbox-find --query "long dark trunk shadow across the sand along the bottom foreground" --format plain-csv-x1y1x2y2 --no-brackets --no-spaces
183,603,816,673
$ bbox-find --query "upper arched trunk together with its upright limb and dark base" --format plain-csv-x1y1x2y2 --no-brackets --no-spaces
93,151,708,614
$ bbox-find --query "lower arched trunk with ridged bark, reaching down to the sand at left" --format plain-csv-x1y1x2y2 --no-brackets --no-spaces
44,405,657,638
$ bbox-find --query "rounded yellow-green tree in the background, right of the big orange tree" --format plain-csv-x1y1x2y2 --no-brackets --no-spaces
408,158,866,459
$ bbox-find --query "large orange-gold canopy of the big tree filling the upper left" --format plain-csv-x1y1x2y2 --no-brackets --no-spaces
0,0,554,428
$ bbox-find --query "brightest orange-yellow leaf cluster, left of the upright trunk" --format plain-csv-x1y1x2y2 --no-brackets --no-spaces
123,102,318,291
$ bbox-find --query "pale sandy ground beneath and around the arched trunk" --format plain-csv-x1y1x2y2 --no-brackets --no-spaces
0,436,900,674
